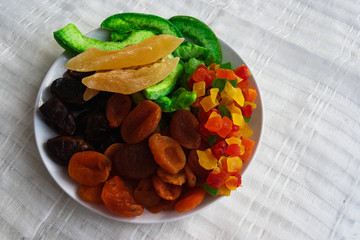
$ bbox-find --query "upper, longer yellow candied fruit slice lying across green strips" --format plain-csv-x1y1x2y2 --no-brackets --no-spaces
66,35,184,72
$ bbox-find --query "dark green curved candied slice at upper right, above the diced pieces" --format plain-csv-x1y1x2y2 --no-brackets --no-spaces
169,16,222,64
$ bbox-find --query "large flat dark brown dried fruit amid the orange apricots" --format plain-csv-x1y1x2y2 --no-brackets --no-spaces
113,141,157,179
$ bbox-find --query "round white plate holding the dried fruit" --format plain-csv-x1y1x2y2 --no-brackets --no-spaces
34,29,263,223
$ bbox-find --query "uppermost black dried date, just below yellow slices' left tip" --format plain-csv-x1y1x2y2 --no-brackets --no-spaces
50,78,85,108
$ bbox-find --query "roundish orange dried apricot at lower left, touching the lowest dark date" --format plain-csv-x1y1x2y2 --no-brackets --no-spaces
68,151,111,186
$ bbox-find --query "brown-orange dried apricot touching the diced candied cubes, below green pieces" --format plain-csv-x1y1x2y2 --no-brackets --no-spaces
170,110,201,149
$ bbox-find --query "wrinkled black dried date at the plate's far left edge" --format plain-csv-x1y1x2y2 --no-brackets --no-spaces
39,97,76,135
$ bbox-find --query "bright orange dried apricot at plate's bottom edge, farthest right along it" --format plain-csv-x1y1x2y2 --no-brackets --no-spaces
174,187,206,213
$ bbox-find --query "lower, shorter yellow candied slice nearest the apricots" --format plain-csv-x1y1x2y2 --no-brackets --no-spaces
82,58,179,95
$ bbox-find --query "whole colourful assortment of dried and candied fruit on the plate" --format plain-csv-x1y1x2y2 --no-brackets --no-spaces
40,13,257,217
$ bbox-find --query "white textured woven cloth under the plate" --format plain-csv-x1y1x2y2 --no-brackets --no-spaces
0,0,360,240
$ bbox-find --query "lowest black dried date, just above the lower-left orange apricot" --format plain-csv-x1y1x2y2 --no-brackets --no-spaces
46,136,93,166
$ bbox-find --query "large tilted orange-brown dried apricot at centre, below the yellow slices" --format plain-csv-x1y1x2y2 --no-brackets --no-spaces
121,100,161,144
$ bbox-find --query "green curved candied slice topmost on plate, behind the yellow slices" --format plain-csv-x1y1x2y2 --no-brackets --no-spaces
101,13,183,37
